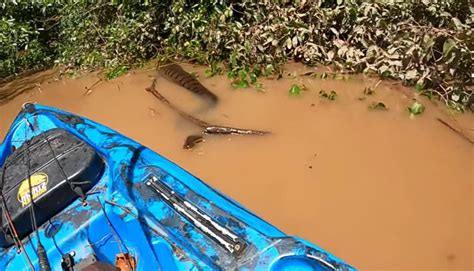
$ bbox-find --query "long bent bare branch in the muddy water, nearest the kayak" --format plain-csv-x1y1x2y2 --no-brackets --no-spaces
145,79,270,135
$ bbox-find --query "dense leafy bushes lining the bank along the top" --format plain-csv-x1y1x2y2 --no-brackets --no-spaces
0,0,474,110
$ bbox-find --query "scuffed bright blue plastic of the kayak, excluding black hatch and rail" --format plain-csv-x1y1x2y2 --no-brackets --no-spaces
0,104,355,271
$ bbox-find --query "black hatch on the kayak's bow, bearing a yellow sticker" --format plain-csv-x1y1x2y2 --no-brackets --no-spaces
0,128,105,248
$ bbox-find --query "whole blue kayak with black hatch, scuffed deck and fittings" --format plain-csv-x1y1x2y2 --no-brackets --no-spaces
0,103,355,271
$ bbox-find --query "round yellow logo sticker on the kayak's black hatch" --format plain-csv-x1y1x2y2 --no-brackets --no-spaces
17,173,48,207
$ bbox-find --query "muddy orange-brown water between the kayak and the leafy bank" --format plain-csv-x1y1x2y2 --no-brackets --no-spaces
0,65,474,270
